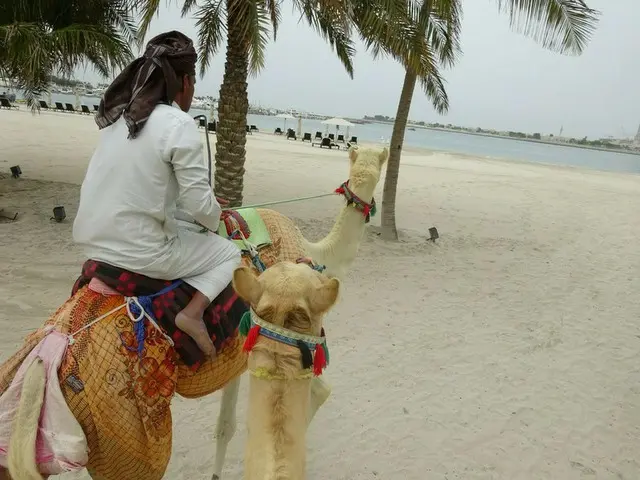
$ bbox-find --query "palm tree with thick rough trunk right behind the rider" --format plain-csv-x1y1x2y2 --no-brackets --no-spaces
138,0,440,206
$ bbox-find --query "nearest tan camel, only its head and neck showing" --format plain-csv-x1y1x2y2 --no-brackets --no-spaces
233,262,340,480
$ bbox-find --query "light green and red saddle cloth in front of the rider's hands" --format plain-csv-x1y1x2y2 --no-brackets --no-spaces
217,208,272,251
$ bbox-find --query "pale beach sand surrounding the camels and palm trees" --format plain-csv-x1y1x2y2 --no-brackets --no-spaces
0,112,640,480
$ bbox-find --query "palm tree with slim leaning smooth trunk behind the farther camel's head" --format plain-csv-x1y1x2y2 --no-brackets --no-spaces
381,0,599,240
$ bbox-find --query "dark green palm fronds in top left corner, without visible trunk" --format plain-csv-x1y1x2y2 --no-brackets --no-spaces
0,0,137,108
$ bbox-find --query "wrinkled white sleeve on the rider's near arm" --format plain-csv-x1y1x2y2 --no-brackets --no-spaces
165,114,222,232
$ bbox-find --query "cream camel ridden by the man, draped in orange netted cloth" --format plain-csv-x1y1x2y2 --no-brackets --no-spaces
0,144,388,480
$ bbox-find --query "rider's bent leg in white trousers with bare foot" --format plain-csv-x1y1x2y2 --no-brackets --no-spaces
176,232,241,355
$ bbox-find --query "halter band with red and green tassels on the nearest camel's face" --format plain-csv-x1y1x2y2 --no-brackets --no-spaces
240,308,329,380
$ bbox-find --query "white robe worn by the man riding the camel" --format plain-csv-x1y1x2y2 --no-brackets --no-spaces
73,104,240,300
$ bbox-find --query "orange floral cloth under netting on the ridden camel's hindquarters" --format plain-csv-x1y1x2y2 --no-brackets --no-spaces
0,286,246,480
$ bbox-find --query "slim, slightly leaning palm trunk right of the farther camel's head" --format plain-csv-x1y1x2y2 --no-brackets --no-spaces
381,69,417,240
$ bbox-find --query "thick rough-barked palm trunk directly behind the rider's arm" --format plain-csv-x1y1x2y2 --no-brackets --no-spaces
214,0,249,207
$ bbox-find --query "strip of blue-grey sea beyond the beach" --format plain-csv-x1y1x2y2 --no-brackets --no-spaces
32,94,640,174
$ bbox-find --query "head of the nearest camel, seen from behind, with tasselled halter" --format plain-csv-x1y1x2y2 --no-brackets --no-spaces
233,262,340,378
